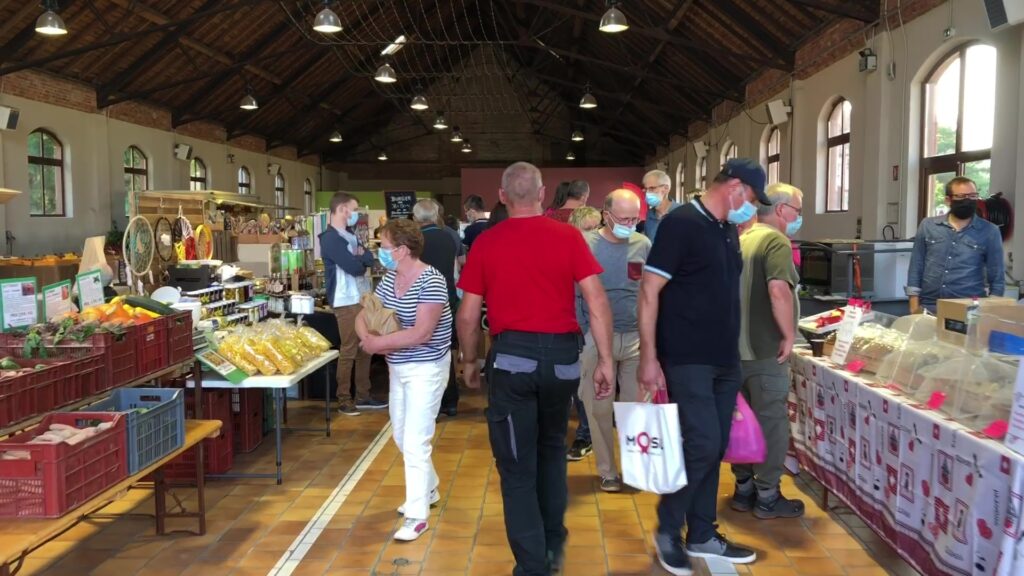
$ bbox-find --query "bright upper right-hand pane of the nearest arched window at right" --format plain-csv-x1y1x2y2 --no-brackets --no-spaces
962,44,995,151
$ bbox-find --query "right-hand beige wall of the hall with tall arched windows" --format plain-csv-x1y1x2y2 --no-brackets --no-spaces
651,0,1024,275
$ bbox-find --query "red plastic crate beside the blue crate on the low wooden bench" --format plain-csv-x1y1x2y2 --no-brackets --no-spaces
0,412,128,518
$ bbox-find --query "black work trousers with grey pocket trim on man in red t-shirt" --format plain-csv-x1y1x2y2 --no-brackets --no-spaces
485,332,583,576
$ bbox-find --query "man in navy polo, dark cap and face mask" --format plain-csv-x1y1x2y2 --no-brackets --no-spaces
637,158,769,575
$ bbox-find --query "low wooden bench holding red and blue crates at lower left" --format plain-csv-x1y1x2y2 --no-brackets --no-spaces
0,420,222,576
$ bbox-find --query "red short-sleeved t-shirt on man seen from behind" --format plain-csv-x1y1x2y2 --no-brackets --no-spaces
459,216,603,335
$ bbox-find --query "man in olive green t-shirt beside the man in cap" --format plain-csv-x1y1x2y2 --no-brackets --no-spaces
731,183,804,520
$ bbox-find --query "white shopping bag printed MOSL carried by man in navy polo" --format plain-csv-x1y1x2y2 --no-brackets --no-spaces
614,393,686,494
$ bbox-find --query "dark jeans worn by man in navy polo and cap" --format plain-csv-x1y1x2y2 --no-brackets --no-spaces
657,363,742,544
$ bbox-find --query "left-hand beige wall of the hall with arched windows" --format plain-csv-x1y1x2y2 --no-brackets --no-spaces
0,94,338,256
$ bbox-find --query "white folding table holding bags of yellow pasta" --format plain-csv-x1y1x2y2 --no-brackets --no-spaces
187,351,338,484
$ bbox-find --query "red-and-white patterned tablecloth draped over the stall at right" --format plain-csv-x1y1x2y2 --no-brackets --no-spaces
788,351,1024,576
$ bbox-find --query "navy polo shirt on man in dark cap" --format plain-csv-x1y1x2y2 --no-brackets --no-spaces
644,199,743,367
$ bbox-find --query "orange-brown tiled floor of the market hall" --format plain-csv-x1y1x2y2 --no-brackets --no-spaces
22,383,914,576
